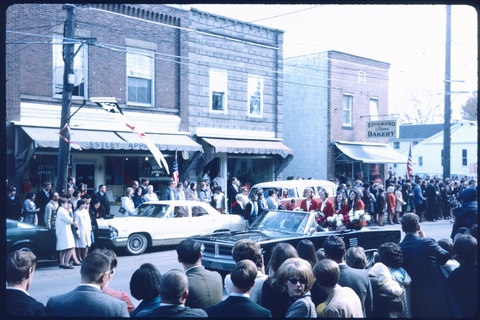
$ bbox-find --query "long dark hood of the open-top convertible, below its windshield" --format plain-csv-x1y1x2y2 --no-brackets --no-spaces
191,230,301,244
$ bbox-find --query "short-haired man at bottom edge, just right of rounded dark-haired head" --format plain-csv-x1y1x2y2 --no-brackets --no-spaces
137,269,207,318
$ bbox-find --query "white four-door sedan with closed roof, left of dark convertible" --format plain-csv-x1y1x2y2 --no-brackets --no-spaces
97,201,246,254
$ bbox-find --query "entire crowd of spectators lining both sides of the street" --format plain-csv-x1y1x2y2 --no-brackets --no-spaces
6,172,478,318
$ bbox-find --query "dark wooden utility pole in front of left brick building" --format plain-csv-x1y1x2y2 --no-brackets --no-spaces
56,4,75,195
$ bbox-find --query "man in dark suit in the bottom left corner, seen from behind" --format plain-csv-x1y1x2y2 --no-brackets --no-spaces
6,250,47,317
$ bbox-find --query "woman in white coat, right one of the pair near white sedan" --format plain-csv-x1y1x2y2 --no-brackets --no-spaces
73,199,92,261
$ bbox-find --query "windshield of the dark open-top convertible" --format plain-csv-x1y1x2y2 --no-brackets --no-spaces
250,211,309,233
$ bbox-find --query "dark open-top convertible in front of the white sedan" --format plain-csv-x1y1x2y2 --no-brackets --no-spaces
190,210,401,273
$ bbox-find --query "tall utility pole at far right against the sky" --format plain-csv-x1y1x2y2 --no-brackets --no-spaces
443,4,452,180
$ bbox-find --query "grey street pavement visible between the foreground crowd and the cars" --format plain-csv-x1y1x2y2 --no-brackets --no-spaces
29,220,452,305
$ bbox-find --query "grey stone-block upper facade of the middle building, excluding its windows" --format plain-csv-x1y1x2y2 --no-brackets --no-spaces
188,9,283,136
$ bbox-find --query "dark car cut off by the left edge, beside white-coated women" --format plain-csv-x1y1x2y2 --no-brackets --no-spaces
7,219,57,260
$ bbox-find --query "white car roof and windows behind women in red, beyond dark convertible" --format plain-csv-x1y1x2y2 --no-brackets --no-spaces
250,180,336,208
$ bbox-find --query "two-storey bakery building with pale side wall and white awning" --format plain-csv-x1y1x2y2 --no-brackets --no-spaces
283,51,406,181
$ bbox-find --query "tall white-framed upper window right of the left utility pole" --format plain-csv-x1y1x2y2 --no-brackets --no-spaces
127,48,155,106
